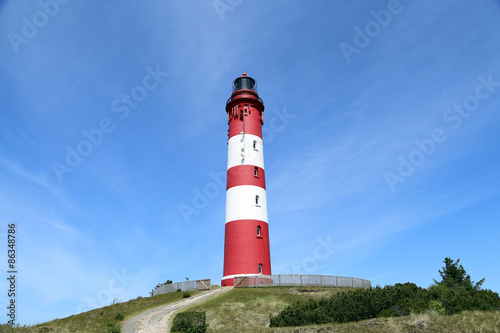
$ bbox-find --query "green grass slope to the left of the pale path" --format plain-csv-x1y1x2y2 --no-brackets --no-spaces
0,291,201,333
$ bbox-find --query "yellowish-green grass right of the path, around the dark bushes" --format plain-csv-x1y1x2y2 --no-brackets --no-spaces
182,287,500,333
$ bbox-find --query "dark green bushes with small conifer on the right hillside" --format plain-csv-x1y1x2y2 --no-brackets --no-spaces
270,258,500,327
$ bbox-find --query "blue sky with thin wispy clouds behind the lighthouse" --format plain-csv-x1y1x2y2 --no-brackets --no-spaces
0,0,500,323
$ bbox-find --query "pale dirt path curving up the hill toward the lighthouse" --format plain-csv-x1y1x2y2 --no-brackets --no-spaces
123,287,233,333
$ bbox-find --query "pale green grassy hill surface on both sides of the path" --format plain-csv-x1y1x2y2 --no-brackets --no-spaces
0,287,500,333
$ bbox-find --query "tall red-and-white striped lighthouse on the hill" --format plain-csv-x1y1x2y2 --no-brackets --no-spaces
221,73,271,286
